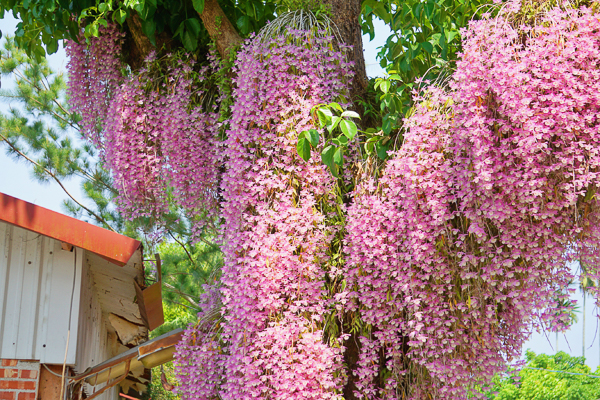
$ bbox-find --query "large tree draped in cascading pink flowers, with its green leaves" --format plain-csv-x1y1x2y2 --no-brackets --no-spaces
0,0,600,400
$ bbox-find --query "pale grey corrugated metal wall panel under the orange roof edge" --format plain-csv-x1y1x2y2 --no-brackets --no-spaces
0,222,84,365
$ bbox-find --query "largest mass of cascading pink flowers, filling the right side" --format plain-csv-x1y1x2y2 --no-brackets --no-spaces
345,2,600,399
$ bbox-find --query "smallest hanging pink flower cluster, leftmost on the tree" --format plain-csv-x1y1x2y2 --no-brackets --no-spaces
65,23,125,149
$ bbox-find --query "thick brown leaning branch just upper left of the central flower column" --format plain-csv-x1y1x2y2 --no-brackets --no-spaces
200,0,242,58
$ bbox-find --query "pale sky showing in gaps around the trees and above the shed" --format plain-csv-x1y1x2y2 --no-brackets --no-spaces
0,13,600,370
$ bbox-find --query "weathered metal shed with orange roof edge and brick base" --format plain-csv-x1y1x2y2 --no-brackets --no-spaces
0,193,162,400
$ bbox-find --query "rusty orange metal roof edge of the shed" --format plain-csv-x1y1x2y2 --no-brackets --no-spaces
0,193,142,266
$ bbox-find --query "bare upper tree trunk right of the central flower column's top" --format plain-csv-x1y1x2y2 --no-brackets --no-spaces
323,0,368,104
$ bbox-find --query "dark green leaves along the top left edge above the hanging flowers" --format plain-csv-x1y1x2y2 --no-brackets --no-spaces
0,0,275,57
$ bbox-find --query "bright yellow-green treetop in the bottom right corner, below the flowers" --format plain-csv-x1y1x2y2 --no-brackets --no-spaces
487,351,600,400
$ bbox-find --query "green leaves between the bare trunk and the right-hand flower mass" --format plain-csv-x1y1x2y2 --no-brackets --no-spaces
361,0,491,159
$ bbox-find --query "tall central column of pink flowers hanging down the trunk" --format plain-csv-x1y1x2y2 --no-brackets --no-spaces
179,31,352,400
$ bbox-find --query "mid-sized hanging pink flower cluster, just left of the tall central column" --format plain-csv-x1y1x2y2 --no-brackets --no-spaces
104,58,219,237
